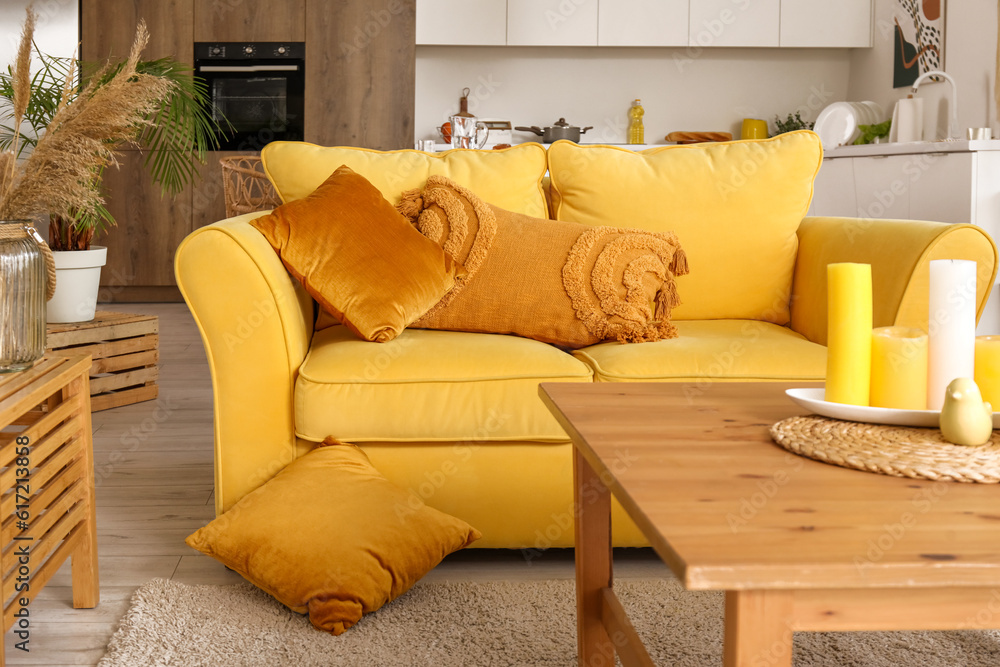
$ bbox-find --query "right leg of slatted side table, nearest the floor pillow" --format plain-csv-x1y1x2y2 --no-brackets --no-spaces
64,373,101,609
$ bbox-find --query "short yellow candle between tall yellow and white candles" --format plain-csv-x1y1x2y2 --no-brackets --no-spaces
871,327,927,410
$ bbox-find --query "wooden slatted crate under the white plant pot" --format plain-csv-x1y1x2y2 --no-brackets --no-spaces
47,311,160,412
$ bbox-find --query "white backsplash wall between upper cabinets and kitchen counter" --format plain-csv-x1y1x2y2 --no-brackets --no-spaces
415,46,851,144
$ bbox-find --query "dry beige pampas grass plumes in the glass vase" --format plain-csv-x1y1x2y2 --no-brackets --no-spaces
0,7,175,220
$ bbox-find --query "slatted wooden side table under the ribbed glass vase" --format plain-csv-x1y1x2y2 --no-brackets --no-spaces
0,354,100,667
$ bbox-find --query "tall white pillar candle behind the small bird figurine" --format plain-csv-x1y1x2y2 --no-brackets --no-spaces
927,259,976,410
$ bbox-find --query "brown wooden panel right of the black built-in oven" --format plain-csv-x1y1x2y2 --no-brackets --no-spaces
305,0,416,150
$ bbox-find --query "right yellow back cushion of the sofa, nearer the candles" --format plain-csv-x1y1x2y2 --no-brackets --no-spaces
549,131,823,324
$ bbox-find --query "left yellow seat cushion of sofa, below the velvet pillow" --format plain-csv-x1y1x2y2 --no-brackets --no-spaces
295,326,593,442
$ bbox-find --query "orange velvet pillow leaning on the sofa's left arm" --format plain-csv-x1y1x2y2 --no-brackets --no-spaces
250,166,464,343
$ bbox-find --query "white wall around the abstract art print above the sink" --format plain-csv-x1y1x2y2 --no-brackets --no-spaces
848,0,1000,138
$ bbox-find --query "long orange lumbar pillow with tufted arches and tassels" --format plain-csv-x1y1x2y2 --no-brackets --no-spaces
397,176,688,348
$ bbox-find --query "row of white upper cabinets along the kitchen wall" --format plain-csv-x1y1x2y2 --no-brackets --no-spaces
416,0,873,48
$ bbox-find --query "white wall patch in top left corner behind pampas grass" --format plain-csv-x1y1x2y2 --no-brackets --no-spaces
0,0,80,66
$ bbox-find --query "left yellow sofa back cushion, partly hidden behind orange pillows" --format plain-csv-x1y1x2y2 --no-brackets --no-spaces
261,141,547,217
